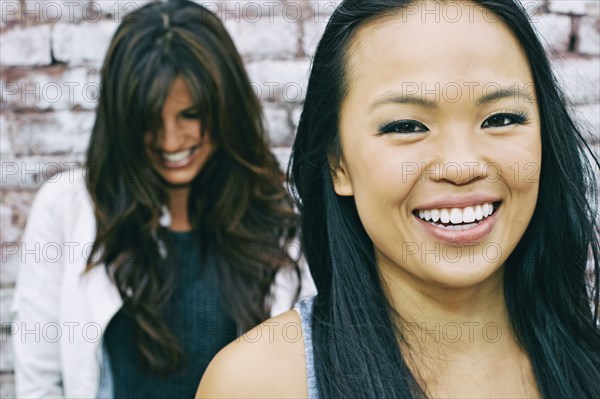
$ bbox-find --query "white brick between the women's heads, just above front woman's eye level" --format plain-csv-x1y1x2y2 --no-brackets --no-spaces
247,59,310,103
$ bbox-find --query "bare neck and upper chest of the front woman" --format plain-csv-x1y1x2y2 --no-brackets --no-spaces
378,264,539,397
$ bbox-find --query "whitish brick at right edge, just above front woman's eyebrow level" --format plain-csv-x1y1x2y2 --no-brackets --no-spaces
553,58,600,104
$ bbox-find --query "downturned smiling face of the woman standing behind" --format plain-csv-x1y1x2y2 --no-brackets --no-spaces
145,77,213,186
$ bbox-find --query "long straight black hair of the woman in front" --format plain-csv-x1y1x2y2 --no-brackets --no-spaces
288,0,600,398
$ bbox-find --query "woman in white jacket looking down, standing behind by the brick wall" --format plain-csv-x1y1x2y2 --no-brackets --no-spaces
14,1,310,398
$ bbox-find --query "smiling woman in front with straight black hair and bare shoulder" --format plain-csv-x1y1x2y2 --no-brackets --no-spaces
197,0,600,399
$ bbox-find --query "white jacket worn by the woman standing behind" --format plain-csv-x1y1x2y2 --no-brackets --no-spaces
12,170,315,398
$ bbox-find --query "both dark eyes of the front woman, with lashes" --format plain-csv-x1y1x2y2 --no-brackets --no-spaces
377,111,529,135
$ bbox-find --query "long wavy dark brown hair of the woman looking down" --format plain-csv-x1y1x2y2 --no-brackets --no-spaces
87,1,298,374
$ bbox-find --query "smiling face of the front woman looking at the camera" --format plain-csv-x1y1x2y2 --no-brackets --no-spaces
334,2,541,288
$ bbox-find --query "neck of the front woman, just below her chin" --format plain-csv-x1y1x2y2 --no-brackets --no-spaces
379,265,516,356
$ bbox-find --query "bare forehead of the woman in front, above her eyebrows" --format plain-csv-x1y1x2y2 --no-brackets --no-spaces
346,1,532,103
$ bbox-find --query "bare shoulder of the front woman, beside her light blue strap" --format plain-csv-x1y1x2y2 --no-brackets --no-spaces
196,310,307,398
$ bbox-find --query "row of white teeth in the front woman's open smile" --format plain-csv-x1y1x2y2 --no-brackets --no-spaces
413,201,501,231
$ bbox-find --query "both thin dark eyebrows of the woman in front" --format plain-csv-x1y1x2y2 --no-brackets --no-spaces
369,87,535,110
